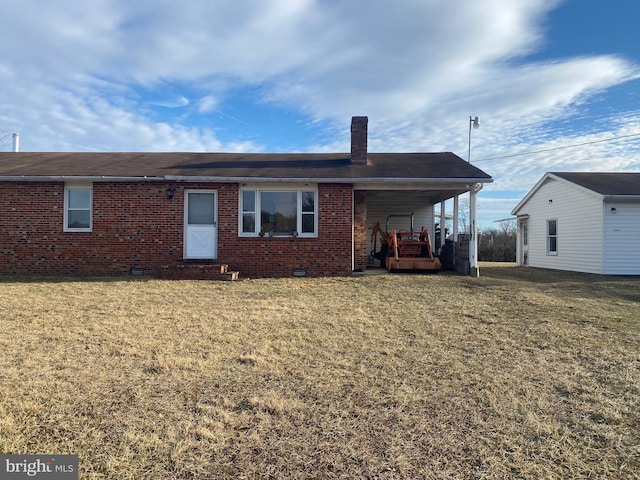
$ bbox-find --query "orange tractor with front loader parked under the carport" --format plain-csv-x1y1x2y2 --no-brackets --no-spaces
370,214,442,272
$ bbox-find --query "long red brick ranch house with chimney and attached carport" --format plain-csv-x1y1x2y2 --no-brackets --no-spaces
0,117,491,277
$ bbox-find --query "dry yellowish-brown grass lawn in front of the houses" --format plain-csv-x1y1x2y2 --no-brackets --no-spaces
0,266,640,479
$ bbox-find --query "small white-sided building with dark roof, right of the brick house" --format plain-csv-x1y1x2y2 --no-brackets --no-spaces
511,172,640,275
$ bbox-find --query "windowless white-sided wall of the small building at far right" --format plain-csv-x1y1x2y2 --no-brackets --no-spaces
603,201,640,275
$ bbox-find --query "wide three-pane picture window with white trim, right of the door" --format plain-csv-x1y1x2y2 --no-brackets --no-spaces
239,188,318,237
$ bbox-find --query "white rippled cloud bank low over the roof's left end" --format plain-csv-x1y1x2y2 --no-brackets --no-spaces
0,69,261,151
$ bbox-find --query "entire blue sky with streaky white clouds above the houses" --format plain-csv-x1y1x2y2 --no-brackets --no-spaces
0,0,640,227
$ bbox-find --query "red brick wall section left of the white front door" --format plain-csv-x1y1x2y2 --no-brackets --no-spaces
0,182,183,275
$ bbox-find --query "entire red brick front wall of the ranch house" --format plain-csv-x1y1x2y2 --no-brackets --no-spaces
0,182,353,277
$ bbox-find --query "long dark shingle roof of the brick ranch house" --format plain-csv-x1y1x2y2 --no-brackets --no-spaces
0,152,491,182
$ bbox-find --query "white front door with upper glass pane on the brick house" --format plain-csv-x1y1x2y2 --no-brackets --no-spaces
184,190,218,259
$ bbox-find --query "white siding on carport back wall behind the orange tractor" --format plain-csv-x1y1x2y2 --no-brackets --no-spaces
367,191,434,258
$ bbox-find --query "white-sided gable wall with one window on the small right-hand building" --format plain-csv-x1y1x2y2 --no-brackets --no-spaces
518,179,603,273
